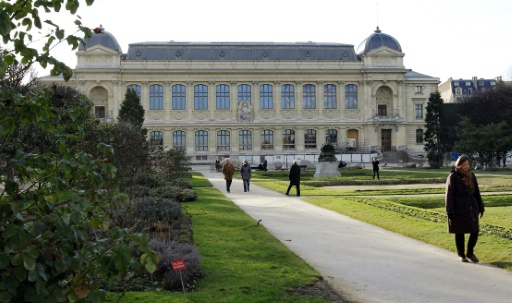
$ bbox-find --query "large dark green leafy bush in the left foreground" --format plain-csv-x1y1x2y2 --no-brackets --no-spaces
0,92,159,303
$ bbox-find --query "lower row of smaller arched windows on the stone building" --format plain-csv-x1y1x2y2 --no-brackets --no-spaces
150,129,423,151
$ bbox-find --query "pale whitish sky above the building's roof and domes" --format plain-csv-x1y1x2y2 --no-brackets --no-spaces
34,0,512,82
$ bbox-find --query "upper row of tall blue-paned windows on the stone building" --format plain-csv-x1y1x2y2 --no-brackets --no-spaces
128,84,358,110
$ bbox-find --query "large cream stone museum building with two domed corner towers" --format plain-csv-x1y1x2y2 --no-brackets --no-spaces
43,27,440,164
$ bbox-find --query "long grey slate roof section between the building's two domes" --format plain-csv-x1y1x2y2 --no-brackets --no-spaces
125,41,357,61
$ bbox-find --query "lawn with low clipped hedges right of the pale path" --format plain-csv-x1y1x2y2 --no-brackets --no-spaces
253,168,512,271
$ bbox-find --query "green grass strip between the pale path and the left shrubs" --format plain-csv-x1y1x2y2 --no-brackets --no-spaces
110,173,327,303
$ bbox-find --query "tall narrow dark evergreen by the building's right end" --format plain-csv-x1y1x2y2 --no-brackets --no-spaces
424,92,445,168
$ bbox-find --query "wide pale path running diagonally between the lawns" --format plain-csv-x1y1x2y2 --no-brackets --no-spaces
201,169,512,303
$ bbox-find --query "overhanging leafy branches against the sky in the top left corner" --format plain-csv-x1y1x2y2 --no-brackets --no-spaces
0,0,94,80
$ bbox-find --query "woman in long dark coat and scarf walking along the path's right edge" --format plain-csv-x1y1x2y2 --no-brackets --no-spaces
445,155,485,263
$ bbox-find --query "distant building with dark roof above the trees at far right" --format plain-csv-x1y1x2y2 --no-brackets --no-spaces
439,76,502,103
